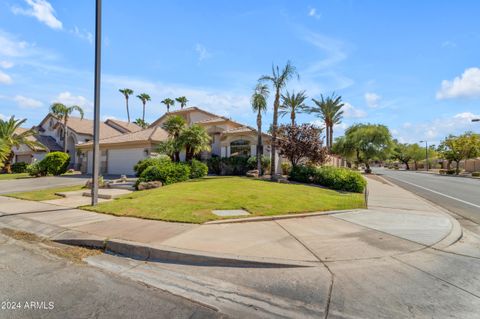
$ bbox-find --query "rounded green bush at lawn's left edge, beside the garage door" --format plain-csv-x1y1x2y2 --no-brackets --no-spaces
137,162,190,185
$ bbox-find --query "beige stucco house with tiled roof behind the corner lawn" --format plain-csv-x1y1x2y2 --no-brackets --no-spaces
77,107,281,175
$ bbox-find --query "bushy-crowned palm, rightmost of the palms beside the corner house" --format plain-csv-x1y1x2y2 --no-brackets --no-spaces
309,93,344,150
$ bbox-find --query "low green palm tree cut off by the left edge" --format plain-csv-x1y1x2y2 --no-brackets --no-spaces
0,116,43,173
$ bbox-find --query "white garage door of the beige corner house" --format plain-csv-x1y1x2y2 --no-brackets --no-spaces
108,148,145,175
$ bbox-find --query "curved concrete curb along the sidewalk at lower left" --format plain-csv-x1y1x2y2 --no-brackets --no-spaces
0,216,319,268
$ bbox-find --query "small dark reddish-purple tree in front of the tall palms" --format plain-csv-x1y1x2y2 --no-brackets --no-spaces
278,124,327,167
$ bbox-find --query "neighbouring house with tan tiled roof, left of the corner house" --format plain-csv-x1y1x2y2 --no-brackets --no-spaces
13,114,142,168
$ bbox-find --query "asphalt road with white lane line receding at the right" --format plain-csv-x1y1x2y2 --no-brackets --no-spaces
374,168,480,224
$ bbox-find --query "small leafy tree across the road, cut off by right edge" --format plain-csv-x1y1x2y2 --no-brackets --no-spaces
439,132,480,175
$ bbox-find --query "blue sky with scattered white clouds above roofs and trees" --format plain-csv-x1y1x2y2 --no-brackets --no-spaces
0,0,480,142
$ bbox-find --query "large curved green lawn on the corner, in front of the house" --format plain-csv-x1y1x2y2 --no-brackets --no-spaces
82,177,364,223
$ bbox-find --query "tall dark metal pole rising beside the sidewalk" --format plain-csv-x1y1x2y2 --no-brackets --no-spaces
92,0,102,206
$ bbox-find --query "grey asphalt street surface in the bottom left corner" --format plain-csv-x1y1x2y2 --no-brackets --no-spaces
0,234,221,319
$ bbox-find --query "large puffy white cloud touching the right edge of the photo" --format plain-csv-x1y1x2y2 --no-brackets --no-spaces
437,67,480,100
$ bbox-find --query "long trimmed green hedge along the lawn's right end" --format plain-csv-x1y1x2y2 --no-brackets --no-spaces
289,165,367,193
